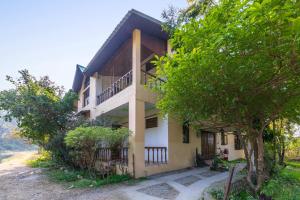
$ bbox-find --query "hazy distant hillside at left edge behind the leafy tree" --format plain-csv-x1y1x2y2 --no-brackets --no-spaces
0,116,36,151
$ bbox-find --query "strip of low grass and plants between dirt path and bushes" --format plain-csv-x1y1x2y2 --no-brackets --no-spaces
27,152,134,188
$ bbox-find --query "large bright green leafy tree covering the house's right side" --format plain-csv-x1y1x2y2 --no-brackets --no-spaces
156,0,300,191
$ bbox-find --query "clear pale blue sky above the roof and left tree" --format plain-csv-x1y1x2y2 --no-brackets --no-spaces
0,0,186,90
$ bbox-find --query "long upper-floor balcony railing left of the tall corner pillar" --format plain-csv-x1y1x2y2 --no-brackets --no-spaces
97,71,132,105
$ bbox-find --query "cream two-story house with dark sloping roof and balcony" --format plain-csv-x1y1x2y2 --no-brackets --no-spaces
73,10,244,177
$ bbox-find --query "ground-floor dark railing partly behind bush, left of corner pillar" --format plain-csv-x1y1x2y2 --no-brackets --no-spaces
96,147,128,165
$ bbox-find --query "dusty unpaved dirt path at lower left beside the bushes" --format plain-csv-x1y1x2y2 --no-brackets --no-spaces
0,151,127,200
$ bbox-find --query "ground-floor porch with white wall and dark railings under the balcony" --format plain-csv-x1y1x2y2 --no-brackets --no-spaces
96,102,168,168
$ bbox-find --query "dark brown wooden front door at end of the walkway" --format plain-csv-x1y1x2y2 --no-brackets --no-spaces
201,132,216,160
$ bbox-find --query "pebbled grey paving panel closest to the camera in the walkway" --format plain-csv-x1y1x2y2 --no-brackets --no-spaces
137,183,179,200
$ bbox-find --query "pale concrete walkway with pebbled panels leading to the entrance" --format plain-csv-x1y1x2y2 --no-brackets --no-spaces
117,166,243,200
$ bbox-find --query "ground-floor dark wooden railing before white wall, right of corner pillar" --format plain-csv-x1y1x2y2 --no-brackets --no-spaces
145,147,168,166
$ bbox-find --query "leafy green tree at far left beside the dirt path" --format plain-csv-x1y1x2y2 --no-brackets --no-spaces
0,70,77,147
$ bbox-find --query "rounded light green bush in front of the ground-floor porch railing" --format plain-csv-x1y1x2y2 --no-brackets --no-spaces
65,126,129,171
